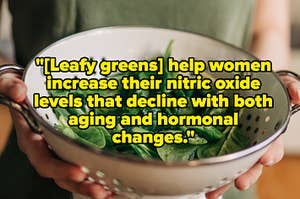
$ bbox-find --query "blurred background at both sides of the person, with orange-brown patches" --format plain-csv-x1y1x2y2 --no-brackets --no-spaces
0,0,300,199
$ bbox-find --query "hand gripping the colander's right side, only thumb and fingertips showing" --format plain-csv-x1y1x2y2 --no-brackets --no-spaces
206,76,300,199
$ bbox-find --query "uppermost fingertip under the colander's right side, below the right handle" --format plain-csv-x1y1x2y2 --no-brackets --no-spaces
260,137,284,167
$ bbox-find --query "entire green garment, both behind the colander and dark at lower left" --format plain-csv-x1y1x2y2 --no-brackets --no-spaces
0,0,255,199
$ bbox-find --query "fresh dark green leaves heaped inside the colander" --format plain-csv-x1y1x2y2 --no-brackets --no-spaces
49,42,250,161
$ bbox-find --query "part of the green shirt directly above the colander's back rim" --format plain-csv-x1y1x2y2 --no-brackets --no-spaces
9,0,255,65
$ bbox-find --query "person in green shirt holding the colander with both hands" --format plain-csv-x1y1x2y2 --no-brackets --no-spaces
0,0,300,199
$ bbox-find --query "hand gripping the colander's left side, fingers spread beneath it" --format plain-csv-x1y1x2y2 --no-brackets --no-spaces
0,74,111,199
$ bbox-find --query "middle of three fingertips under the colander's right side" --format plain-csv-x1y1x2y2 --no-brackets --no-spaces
235,163,263,190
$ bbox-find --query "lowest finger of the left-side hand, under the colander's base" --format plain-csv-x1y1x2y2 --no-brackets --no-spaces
55,180,112,199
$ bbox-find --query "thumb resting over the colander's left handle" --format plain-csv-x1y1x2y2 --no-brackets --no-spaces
0,74,27,102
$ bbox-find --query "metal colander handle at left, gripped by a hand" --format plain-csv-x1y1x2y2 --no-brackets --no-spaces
0,65,41,133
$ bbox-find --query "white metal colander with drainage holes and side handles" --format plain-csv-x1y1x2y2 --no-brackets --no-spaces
0,27,299,198
